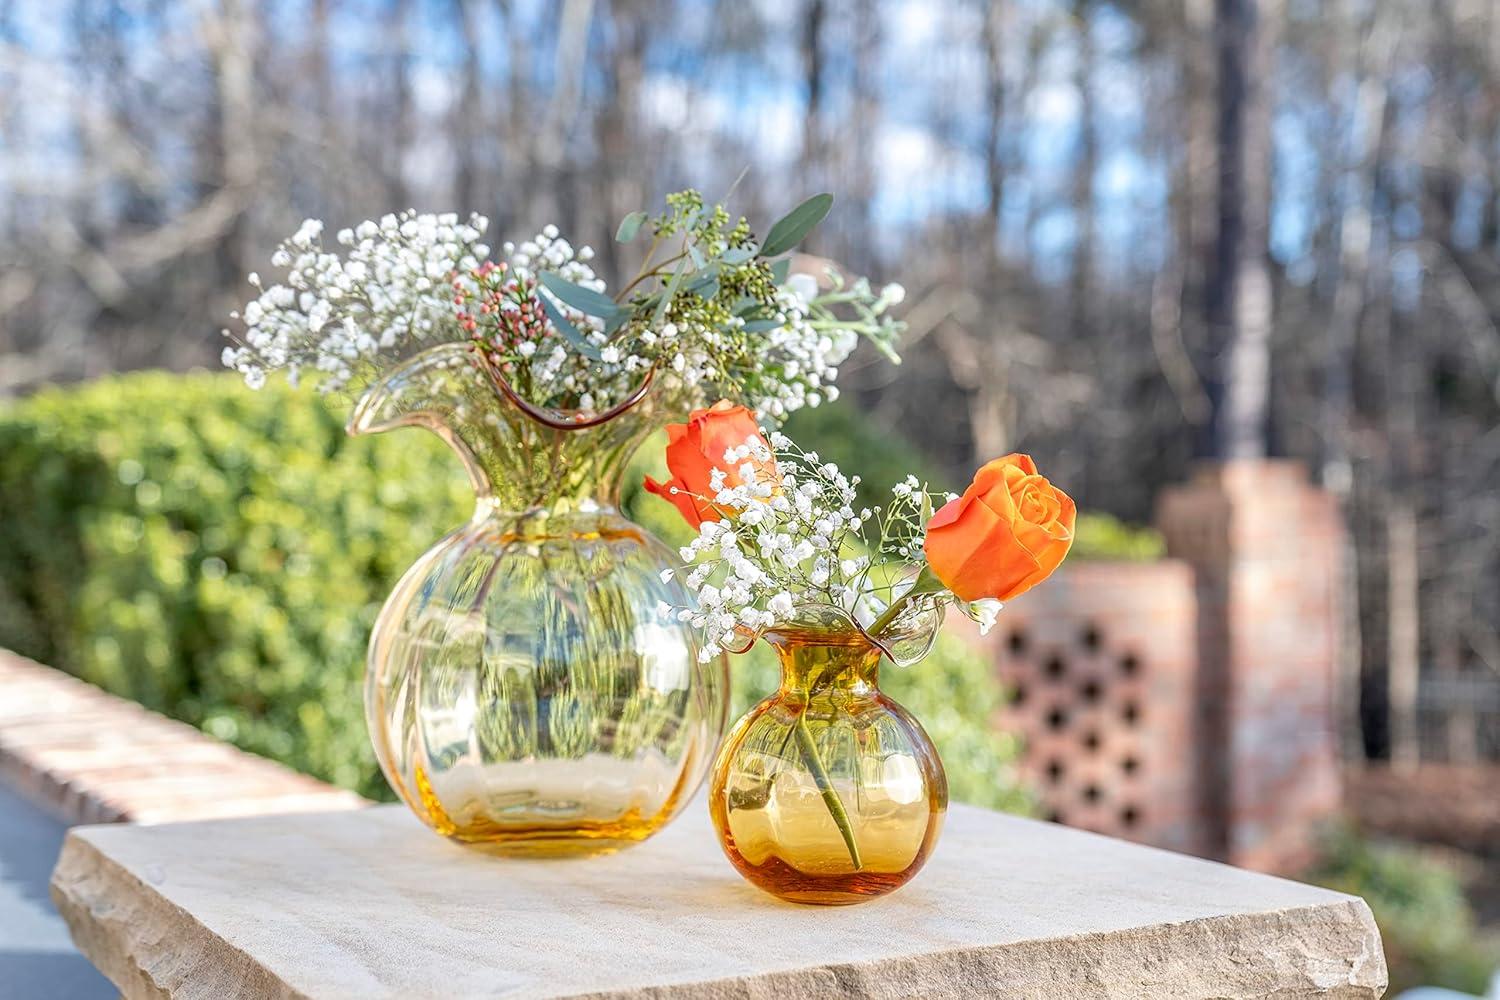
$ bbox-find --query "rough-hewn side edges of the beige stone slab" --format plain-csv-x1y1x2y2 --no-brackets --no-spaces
51,829,1386,1000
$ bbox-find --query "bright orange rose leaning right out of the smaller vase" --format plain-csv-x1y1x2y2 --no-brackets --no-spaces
924,454,1077,601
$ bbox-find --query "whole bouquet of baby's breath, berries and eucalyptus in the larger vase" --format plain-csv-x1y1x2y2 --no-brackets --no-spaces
224,190,905,421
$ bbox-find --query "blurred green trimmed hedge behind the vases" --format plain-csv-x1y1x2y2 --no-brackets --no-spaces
0,373,1026,808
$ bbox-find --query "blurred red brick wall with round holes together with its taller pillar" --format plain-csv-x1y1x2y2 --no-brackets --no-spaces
980,462,1344,871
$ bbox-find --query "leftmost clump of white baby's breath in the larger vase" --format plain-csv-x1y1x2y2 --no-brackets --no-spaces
224,211,489,393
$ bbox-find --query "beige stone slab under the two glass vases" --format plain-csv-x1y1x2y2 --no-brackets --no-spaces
53,801,1386,1000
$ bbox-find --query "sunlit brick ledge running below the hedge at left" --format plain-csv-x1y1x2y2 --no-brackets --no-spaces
0,649,368,823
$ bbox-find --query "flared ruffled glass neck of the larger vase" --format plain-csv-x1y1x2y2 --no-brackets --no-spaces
348,343,656,517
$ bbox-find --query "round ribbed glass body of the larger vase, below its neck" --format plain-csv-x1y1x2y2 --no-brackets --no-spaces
365,503,725,853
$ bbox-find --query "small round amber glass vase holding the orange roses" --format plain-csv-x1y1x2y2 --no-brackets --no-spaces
710,613,948,906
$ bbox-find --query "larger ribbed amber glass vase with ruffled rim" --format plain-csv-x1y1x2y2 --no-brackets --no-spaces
350,345,728,856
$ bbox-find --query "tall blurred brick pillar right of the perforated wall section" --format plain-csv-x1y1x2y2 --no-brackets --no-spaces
1157,460,1343,871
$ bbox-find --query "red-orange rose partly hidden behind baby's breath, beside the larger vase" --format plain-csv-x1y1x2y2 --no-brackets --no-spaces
647,399,777,528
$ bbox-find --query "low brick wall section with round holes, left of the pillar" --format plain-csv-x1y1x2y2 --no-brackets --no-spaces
987,561,1206,853
